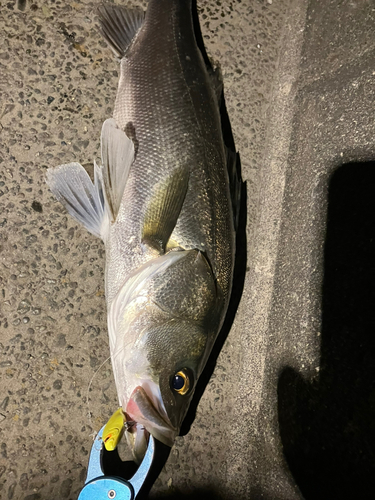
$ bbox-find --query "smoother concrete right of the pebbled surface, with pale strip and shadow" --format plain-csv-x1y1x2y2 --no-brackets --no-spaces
227,0,375,500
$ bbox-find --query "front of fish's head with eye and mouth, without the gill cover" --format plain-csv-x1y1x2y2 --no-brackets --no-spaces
123,318,207,446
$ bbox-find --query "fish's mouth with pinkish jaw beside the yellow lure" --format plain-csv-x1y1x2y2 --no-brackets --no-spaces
125,385,178,447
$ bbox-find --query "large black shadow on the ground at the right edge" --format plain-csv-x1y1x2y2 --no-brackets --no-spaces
278,162,375,500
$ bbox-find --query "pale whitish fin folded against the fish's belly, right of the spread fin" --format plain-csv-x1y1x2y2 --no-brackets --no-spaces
101,118,134,221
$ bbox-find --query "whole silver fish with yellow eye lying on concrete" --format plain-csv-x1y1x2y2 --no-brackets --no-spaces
46,0,240,460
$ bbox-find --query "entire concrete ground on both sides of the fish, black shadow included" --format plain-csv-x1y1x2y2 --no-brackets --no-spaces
0,0,375,500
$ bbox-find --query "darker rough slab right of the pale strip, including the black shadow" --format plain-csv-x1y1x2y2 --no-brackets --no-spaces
278,1,375,499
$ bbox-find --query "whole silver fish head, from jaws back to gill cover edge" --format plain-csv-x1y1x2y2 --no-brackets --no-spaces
112,251,225,457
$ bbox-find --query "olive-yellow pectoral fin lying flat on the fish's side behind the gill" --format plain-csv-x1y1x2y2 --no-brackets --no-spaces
142,168,189,253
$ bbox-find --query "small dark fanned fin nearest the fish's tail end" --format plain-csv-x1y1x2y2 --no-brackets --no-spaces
98,5,145,59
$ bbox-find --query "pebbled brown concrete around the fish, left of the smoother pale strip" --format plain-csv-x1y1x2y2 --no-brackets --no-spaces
0,0,296,500
